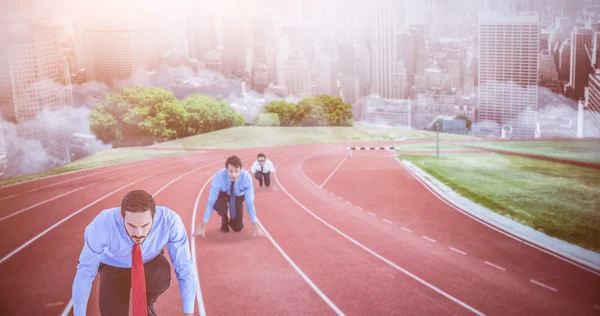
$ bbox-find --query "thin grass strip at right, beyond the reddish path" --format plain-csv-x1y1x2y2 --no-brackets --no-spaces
469,141,600,162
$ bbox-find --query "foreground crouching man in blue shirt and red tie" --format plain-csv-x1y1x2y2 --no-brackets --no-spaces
72,190,197,316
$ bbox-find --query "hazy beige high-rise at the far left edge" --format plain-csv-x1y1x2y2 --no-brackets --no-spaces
0,20,73,167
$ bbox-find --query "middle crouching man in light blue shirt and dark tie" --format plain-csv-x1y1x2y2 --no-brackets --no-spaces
196,156,264,237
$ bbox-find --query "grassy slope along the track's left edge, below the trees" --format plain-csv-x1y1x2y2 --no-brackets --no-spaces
0,148,190,187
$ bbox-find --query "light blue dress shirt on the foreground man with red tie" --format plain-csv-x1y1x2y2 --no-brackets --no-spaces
72,206,197,316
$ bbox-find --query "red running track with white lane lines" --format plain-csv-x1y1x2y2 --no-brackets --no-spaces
0,143,600,315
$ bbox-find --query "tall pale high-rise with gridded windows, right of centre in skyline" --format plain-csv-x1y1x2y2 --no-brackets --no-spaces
478,13,540,138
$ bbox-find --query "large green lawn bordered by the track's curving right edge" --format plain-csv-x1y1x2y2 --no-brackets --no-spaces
401,155,600,251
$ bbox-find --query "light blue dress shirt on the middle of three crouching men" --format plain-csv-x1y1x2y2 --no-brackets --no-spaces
204,168,256,224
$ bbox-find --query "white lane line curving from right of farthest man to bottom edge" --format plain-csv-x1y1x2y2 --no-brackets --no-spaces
275,158,484,315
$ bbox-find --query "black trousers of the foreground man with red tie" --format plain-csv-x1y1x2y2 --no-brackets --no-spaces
98,252,171,316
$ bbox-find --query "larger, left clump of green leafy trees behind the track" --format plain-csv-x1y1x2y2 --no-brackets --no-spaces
90,86,246,145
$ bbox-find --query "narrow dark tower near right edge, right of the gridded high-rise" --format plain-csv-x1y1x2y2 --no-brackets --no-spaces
569,27,594,99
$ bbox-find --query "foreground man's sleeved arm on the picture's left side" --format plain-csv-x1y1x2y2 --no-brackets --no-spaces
72,217,106,316
